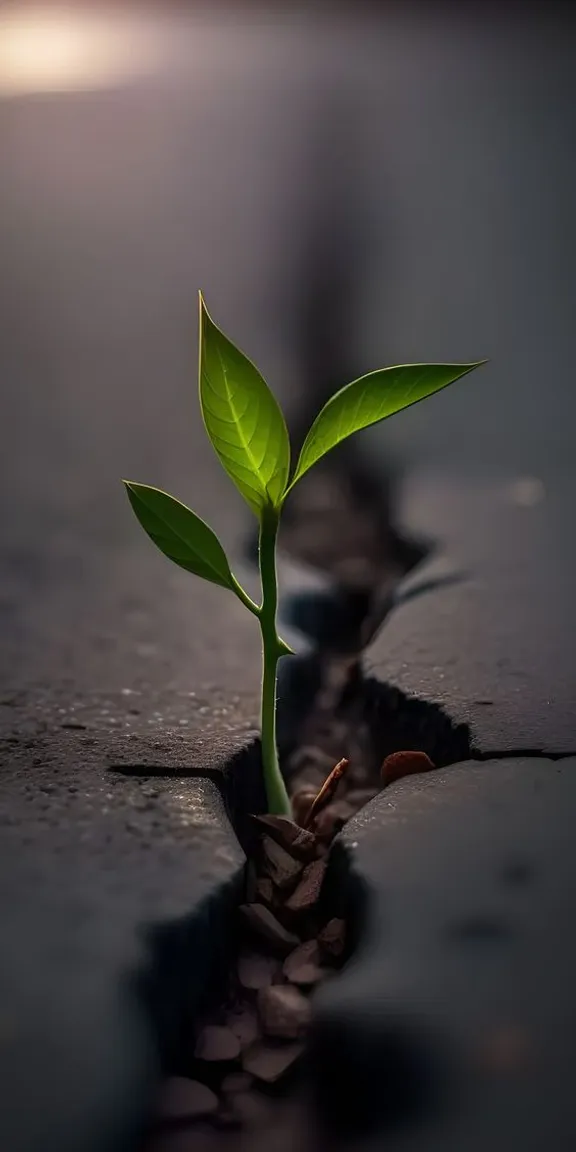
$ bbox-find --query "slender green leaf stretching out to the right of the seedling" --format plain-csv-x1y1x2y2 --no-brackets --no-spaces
288,361,486,492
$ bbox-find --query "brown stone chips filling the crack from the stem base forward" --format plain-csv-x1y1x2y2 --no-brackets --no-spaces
147,765,353,1152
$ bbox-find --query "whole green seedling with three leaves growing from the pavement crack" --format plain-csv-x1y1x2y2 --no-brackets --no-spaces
124,294,485,816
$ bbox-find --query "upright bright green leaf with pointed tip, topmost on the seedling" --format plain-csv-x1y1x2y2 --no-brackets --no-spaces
199,294,290,518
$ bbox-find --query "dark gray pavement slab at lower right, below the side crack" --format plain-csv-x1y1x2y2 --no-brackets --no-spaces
314,758,576,1152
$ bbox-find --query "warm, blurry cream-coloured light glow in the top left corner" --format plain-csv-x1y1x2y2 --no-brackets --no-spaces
0,8,162,96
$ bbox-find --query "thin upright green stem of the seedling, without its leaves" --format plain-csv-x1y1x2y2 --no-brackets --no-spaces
259,509,291,816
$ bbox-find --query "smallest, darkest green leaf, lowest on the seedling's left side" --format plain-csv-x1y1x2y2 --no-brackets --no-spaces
124,480,237,592
